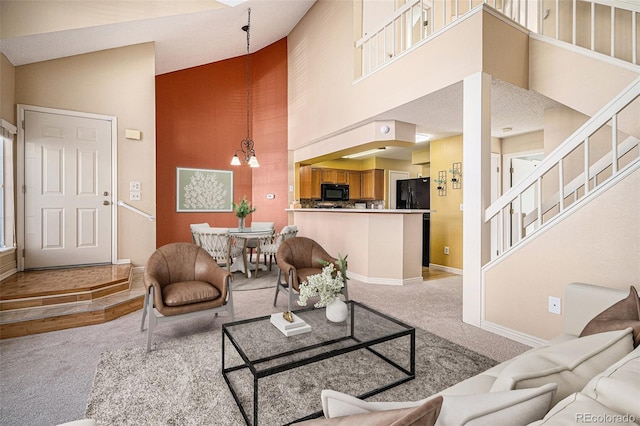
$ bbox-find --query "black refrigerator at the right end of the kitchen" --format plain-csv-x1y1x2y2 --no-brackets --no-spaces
396,178,431,267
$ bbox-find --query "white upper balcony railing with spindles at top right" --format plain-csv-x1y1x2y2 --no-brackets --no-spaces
356,0,640,77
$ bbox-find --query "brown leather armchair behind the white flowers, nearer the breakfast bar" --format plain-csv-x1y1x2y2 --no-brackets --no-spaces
273,237,349,311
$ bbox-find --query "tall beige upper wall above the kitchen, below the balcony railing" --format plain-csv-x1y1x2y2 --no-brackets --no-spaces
287,0,490,151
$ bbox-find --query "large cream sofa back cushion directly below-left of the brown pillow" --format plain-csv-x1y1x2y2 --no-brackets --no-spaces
491,328,633,404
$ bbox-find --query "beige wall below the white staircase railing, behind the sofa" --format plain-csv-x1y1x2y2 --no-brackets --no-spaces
485,167,640,339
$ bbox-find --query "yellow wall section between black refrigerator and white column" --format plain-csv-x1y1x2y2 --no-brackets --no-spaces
430,136,465,270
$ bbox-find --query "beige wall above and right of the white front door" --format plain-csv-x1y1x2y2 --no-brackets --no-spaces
16,43,156,265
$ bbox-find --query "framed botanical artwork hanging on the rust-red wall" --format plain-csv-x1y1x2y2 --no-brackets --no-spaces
176,167,233,212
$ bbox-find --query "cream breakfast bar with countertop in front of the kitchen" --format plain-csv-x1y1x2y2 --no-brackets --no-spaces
287,208,435,285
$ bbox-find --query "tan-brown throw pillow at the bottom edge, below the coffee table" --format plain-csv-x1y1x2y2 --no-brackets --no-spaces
298,396,442,426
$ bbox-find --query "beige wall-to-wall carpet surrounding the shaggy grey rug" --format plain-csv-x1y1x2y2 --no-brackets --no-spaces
0,276,528,426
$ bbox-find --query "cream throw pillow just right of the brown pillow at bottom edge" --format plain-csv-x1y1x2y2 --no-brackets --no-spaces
432,383,557,426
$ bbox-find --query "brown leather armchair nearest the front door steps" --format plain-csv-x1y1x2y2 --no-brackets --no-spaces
140,243,233,352
